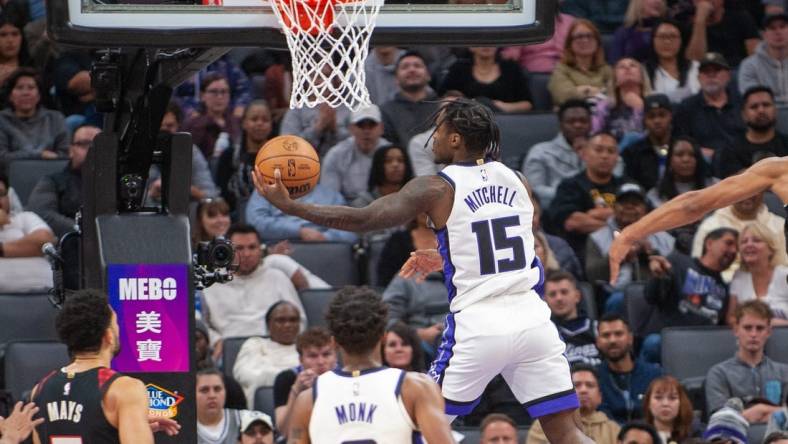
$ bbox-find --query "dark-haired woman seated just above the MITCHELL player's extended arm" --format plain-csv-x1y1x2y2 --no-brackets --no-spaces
350,145,413,207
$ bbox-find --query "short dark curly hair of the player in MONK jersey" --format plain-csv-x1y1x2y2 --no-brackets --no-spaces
326,286,388,355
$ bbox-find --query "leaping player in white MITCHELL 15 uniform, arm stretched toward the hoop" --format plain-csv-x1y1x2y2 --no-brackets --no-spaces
253,99,592,444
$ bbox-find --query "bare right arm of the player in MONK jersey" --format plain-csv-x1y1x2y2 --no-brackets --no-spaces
402,373,454,444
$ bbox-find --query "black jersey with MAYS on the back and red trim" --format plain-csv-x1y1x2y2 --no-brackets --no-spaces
33,367,123,444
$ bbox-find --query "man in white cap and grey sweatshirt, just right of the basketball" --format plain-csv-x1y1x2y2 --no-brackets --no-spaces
320,105,389,202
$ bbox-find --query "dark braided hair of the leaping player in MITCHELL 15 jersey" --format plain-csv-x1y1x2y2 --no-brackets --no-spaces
430,98,501,160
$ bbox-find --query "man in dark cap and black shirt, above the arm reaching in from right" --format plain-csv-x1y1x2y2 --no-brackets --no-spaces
673,53,744,160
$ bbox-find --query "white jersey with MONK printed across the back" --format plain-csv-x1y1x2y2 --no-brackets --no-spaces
309,367,422,444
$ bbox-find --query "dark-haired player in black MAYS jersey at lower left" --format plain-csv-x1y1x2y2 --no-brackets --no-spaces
32,290,179,444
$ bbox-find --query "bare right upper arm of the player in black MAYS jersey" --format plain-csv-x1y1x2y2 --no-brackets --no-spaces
114,376,153,444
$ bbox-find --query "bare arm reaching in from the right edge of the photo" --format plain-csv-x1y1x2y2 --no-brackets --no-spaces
608,158,788,283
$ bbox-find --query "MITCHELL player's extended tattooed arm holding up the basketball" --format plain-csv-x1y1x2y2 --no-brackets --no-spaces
252,170,451,232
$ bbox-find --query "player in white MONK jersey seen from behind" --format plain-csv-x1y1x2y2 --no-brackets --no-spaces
287,287,454,444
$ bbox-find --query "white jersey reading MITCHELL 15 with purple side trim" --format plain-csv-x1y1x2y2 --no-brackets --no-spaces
436,161,549,314
